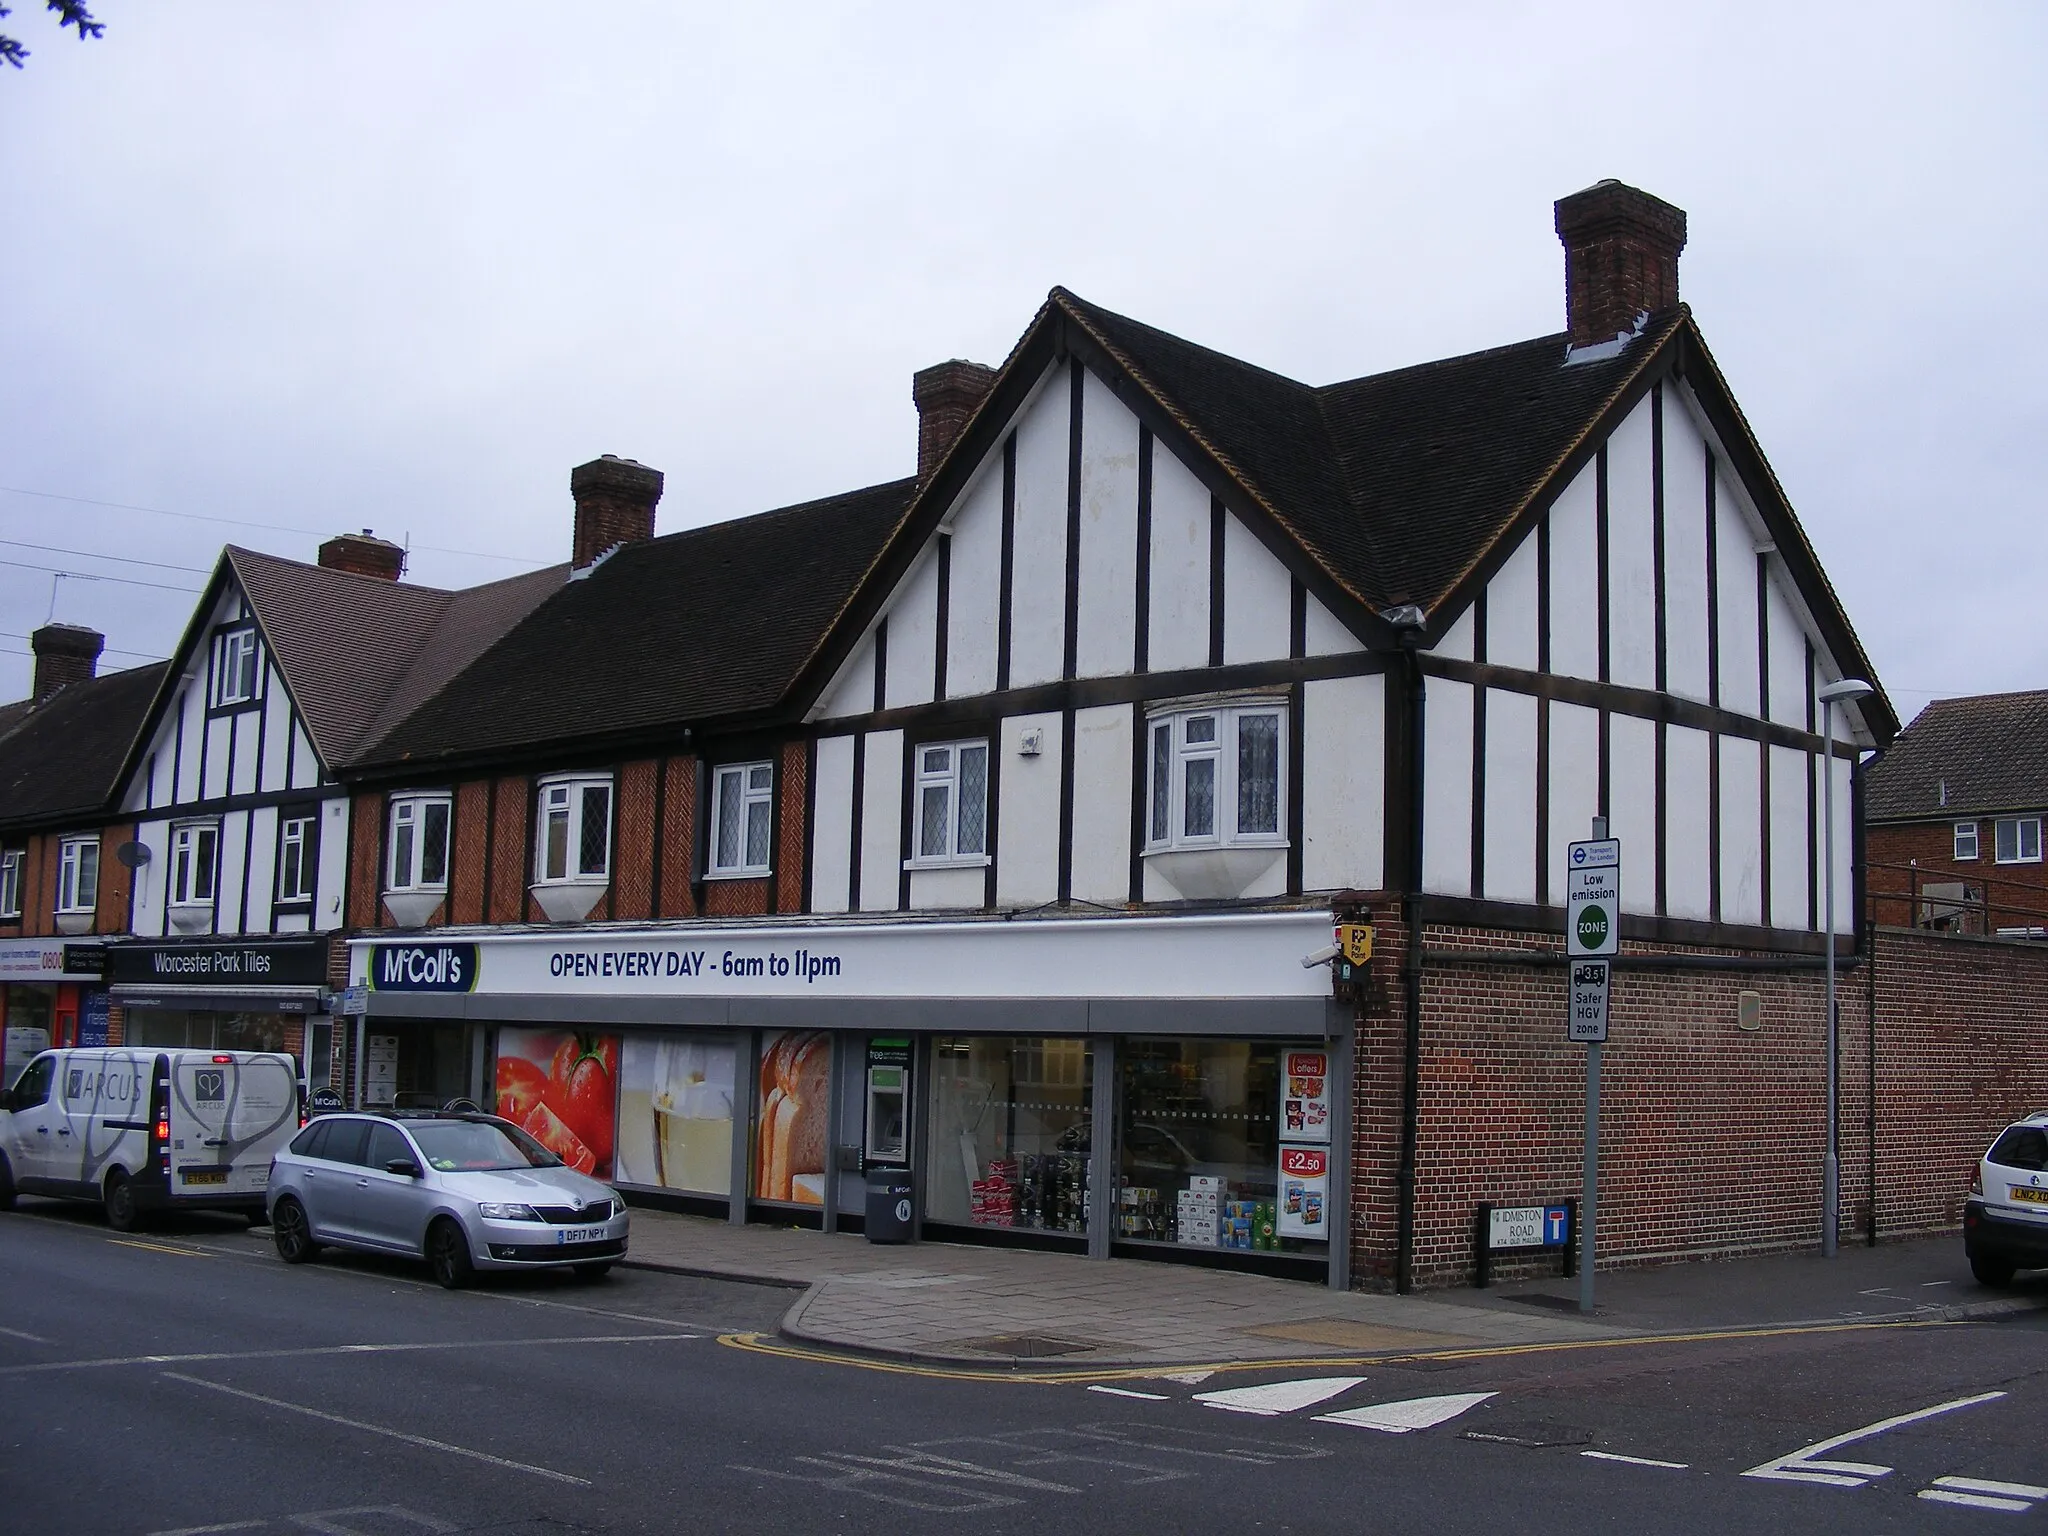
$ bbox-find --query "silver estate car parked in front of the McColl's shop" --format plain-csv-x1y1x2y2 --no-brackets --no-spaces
266,1112,627,1288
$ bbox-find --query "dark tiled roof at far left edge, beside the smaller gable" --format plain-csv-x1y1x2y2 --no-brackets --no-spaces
0,662,170,827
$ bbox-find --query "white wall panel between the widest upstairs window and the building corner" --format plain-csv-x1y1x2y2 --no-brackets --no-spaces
1300,674,1384,891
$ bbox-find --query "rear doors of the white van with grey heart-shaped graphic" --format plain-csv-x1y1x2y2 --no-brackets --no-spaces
170,1051,299,1198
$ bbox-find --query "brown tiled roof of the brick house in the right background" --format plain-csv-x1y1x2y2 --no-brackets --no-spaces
1864,690,2048,821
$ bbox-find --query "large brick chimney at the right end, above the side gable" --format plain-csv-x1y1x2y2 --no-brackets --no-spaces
1556,180,1686,346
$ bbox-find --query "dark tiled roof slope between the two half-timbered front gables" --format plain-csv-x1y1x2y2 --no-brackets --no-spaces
358,479,915,770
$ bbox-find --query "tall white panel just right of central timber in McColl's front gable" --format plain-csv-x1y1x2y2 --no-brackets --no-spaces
1073,373,1163,679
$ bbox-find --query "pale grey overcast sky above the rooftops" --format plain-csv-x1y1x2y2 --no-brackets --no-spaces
0,0,2048,717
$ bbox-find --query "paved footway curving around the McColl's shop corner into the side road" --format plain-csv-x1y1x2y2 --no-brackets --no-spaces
629,1210,2048,1370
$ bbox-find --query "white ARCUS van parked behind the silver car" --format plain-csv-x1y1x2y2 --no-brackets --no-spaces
0,1047,305,1231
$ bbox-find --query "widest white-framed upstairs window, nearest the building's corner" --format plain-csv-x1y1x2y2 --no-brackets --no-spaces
1145,702,1286,852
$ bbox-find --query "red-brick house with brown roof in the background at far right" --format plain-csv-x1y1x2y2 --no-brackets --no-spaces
1864,690,2048,938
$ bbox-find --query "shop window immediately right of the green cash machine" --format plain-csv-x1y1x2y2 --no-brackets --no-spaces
926,1036,1094,1237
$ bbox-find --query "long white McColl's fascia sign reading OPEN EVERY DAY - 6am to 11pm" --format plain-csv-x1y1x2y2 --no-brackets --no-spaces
348,911,1331,997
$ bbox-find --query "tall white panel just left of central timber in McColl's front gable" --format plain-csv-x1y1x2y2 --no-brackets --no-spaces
1010,365,1069,688
